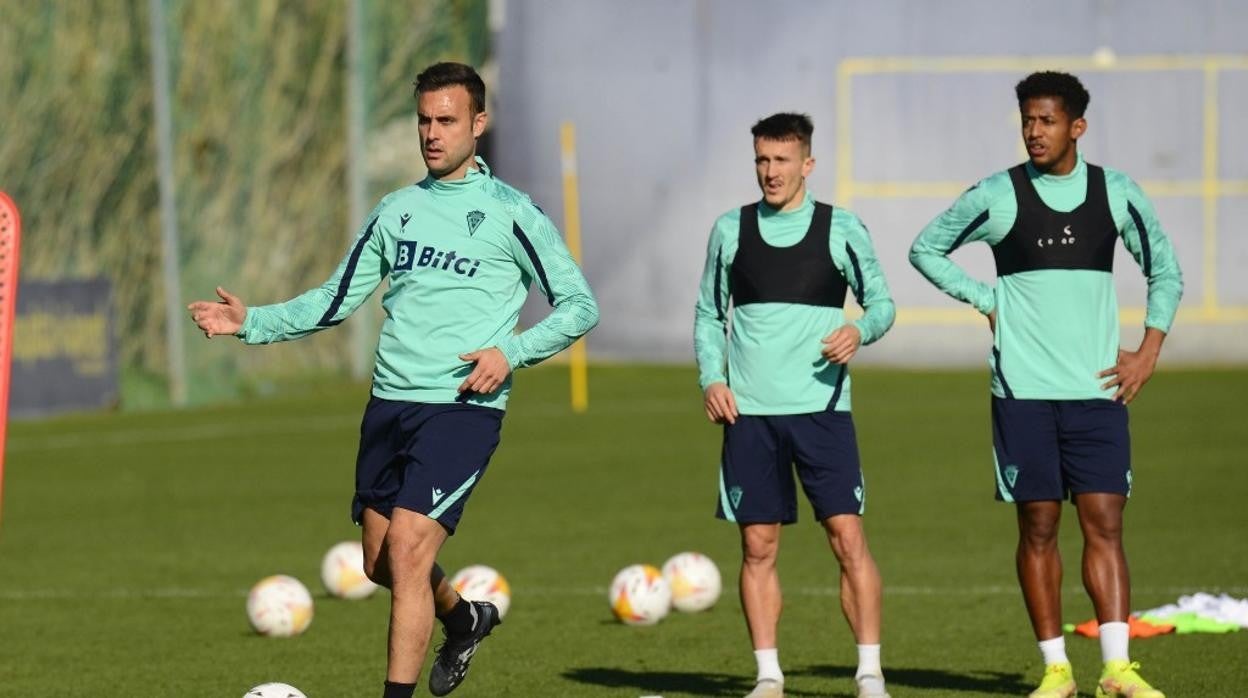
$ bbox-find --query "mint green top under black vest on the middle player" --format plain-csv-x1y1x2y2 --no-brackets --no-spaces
694,192,895,415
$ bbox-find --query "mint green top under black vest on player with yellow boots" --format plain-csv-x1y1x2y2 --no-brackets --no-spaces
910,155,1183,400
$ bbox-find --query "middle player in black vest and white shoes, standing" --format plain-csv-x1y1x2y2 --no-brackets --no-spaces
694,114,894,698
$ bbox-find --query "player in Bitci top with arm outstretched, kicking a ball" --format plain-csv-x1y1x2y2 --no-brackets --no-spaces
190,62,598,698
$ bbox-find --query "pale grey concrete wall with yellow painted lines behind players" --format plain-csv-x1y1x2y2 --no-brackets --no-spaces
493,0,1248,365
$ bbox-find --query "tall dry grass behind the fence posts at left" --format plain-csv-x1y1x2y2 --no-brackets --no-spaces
0,0,488,397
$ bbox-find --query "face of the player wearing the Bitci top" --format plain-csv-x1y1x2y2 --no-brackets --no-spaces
416,85,485,180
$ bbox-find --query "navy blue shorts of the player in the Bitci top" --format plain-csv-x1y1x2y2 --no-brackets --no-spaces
351,396,503,534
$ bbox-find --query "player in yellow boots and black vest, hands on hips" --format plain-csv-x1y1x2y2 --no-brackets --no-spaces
910,72,1183,698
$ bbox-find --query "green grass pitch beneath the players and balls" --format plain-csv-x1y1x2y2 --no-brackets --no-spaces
0,366,1248,698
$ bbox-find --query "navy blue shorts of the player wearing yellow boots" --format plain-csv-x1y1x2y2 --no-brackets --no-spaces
992,396,1131,502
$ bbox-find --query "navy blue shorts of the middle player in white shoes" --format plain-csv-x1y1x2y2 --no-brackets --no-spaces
715,411,866,523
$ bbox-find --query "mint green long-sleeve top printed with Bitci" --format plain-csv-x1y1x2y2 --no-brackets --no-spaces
238,157,598,408
